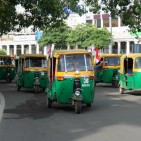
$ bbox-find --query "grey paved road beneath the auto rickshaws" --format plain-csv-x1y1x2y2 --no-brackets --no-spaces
0,82,141,141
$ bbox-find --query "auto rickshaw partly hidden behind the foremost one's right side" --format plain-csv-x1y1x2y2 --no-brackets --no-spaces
94,54,121,87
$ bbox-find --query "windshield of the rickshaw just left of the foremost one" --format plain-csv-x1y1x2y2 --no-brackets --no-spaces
25,57,47,68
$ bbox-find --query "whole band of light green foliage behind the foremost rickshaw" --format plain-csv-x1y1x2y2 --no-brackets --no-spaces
38,24,110,48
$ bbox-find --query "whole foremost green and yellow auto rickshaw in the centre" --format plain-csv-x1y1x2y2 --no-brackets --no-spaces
46,50,95,114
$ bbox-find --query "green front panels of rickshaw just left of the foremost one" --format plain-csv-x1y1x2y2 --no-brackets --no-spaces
17,71,47,88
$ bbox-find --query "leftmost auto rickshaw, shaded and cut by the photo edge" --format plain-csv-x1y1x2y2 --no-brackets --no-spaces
0,55,16,82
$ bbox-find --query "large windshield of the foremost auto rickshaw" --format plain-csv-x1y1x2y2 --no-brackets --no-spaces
57,54,92,72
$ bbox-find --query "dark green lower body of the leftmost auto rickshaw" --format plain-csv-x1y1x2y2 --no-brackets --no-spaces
0,67,16,80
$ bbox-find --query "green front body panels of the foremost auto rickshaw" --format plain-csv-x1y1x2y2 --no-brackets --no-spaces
46,78,95,104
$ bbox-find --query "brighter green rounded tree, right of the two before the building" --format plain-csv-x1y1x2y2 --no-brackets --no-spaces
67,24,111,48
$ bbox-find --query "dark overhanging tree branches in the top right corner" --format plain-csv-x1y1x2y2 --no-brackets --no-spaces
85,0,141,33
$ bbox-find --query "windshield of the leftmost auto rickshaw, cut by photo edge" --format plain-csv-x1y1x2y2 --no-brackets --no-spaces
0,57,14,65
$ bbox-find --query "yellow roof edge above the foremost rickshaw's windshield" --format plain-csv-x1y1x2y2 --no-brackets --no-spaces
53,49,92,57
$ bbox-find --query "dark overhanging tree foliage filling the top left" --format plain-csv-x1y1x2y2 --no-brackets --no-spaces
0,0,84,35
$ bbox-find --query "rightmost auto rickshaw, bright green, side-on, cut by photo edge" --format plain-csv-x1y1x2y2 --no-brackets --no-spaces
119,53,141,94
